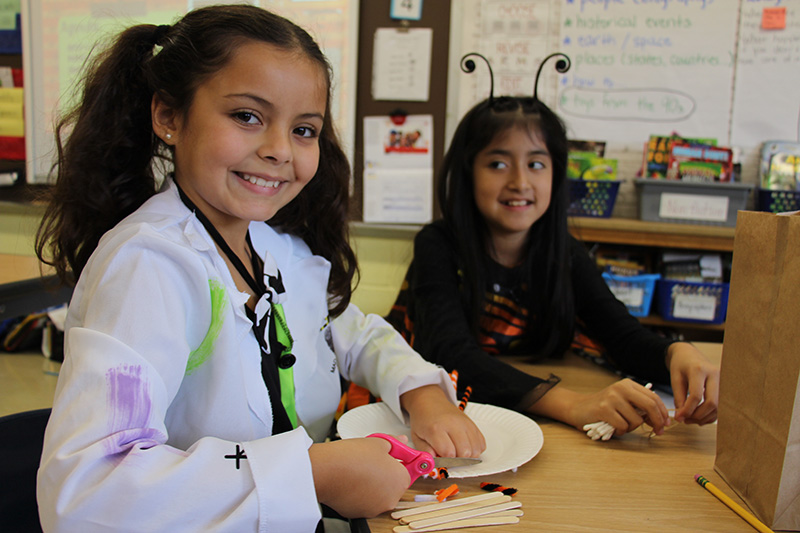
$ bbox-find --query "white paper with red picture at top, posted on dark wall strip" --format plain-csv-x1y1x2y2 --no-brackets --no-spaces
363,115,433,224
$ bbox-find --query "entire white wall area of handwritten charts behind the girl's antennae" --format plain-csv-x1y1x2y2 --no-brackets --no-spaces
447,0,800,153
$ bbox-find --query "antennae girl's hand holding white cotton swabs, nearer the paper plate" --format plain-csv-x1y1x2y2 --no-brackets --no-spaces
531,379,669,435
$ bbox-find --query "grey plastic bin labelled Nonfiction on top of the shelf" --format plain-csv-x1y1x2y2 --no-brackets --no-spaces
634,178,755,227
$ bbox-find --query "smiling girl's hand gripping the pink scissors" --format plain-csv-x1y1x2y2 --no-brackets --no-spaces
308,438,411,518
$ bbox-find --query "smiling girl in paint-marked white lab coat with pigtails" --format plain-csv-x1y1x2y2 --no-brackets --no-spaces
37,5,485,532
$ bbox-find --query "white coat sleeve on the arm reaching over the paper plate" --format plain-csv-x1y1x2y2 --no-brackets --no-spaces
331,304,457,420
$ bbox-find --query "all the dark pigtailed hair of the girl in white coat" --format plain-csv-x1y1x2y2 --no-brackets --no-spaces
36,5,357,315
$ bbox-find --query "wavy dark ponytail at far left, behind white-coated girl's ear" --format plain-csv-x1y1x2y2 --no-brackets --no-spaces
36,24,165,283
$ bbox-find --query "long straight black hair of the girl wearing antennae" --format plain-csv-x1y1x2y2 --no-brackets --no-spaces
437,96,575,355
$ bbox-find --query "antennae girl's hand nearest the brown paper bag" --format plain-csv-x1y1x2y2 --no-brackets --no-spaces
666,342,719,425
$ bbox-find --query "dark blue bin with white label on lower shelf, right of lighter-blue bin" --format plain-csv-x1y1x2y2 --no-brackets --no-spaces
656,279,728,324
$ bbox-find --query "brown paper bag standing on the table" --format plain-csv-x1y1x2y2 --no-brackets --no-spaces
714,211,800,531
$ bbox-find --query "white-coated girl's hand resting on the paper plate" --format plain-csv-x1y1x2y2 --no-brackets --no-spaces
400,385,486,457
